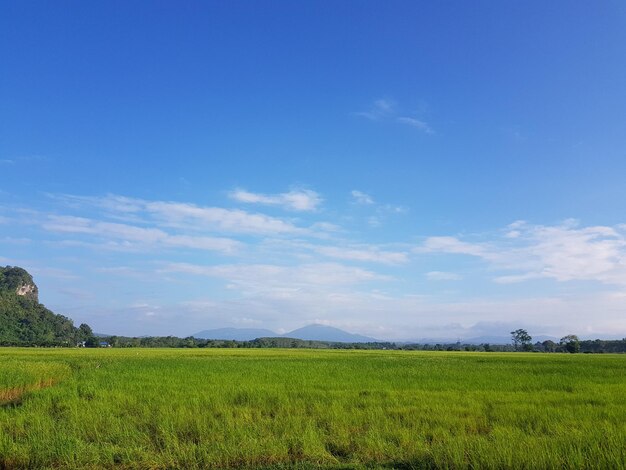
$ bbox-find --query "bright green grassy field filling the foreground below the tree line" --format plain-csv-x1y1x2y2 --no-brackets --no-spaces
0,348,626,469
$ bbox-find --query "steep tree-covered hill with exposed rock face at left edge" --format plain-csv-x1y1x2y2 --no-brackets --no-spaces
0,266,95,346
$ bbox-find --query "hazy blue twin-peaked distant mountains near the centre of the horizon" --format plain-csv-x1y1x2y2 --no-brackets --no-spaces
192,323,378,343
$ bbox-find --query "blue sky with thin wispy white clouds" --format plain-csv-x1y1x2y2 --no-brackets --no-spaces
0,1,626,339
